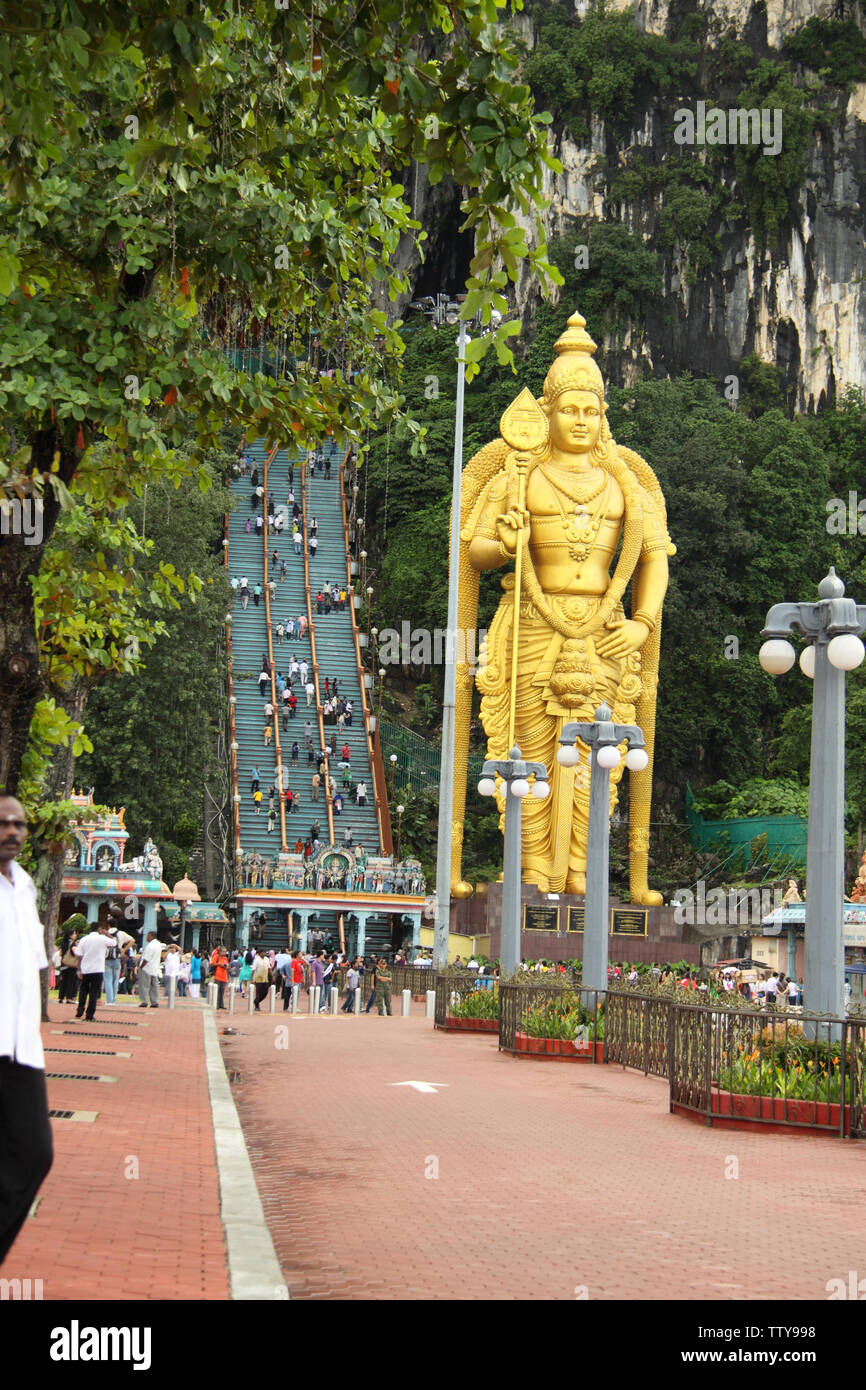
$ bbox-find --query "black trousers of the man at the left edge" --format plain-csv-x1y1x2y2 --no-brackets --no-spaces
0,1056,54,1265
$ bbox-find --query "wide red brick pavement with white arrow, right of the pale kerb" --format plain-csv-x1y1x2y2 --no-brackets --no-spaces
229,1013,866,1300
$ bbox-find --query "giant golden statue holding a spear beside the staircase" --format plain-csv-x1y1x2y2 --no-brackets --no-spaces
452,314,676,904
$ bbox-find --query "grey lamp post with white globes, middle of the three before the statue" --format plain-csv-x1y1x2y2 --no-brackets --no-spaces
556,705,649,990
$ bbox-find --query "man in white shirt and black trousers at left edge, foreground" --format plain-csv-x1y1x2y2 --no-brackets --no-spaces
0,796,53,1265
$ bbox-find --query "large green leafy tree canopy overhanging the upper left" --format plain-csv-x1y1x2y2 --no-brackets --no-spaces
0,0,556,788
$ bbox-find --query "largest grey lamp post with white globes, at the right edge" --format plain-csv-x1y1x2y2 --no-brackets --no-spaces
758,569,866,1017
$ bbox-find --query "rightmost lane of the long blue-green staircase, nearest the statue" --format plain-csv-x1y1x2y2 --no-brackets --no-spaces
304,442,381,855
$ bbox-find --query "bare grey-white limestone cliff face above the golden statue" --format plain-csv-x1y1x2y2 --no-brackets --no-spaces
403,0,866,410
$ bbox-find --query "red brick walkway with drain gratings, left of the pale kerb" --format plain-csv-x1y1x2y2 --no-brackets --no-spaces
3,1001,229,1300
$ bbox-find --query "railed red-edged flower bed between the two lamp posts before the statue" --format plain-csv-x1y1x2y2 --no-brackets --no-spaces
499,976,605,1062
